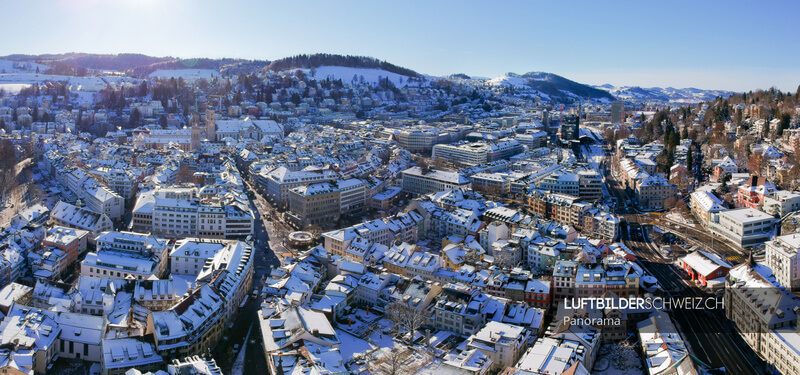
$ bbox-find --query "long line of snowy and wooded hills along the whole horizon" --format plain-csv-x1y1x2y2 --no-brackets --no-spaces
0,52,733,103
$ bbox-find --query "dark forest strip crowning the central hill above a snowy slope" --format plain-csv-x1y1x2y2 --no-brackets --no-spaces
264,53,420,77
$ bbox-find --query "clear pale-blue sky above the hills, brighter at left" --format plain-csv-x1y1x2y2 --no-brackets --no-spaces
0,0,800,92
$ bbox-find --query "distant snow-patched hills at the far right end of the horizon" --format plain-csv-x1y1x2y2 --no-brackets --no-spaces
594,84,733,103
